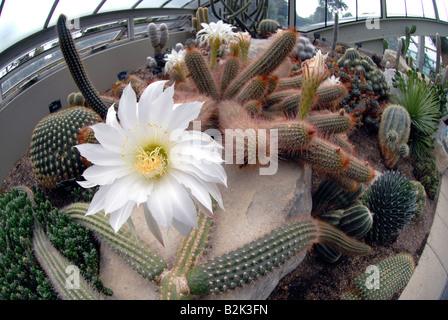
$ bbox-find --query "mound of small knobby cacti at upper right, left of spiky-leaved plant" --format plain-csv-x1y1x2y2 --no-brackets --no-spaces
337,48,388,98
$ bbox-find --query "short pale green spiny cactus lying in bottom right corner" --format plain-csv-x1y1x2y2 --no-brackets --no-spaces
341,253,415,300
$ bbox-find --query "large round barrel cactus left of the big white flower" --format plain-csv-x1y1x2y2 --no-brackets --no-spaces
30,107,101,189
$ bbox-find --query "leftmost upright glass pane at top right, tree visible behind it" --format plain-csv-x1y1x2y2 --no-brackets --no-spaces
296,0,325,32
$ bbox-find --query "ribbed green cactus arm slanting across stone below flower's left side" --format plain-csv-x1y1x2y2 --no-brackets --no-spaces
64,203,166,281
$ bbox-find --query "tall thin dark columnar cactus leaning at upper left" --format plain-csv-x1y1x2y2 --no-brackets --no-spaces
56,14,107,119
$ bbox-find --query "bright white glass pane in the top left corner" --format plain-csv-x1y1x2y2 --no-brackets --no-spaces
0,0,54,52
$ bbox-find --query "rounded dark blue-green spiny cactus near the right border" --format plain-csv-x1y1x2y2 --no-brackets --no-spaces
361,171,417,241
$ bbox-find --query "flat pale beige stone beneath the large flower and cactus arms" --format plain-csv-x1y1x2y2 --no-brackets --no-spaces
100,162,312,300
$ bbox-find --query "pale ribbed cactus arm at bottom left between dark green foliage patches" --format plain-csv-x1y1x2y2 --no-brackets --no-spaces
33,223,102,300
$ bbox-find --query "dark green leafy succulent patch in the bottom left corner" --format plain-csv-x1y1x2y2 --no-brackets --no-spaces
0,190,56,300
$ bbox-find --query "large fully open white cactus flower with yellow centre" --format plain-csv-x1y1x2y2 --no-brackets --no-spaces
76,81,227,244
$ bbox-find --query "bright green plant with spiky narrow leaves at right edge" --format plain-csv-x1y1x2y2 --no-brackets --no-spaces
391,69,446,160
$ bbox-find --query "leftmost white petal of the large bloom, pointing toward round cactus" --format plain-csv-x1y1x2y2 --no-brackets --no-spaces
75,143,126,166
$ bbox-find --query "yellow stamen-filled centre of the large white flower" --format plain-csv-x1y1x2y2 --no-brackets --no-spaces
134,147,168,179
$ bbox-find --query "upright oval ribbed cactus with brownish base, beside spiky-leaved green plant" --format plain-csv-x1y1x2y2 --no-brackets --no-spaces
378,104,411,168
